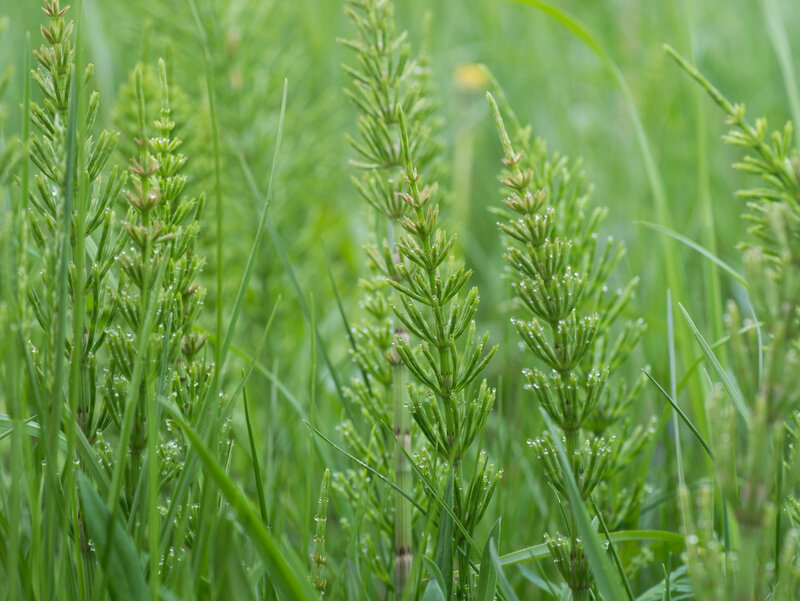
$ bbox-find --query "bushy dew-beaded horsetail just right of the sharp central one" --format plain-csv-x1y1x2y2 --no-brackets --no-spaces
488,94,652,601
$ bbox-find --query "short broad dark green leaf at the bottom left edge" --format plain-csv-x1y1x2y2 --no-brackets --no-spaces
78,472,150,601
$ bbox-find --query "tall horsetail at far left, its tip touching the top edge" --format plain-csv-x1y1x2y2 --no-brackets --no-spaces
28,0,126,441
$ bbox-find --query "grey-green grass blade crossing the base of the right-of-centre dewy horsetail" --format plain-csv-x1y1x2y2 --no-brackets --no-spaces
539,408,626,601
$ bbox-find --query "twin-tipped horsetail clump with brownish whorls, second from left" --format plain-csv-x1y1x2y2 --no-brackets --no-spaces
105,56,213,508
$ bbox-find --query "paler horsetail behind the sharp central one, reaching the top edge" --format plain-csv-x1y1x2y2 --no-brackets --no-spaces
337,0,440,598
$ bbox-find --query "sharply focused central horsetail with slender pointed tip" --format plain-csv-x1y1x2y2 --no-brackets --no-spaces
394,106,502,599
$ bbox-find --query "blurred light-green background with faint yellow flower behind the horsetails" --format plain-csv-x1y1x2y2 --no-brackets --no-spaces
0,0,800,592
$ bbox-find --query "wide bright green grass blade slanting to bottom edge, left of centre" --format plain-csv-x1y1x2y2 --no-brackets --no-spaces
164,403,319,601
